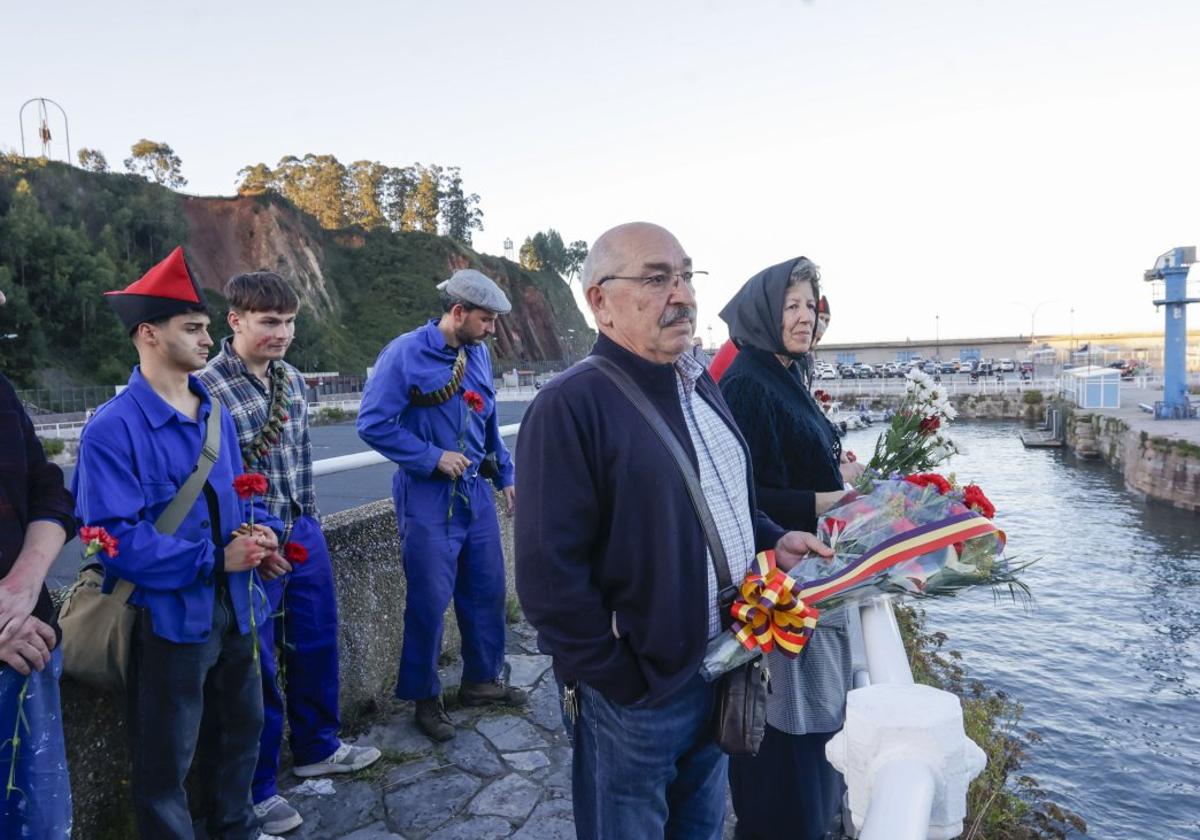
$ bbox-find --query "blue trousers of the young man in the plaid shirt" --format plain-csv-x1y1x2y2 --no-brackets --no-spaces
253,516,341,803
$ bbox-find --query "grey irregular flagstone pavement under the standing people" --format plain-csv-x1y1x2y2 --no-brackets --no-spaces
273,622,732,840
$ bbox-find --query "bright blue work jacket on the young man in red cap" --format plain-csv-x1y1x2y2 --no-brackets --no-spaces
72,367,283,643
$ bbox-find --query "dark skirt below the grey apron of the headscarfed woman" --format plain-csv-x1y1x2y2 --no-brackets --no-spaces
730,726,846,840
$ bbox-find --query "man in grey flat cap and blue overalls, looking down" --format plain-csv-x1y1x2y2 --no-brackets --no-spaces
358,269,526,740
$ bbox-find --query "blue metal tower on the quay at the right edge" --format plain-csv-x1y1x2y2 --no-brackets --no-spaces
1144,245,1200,420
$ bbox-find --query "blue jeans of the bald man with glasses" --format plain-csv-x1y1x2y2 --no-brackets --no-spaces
571,674,728,840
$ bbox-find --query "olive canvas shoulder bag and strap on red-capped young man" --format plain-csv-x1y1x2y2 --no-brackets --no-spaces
59,400,221,691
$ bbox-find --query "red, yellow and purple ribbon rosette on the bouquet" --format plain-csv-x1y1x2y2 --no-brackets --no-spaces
731,550,820,656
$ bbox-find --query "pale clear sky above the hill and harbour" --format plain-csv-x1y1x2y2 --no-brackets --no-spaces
0,0,1200,342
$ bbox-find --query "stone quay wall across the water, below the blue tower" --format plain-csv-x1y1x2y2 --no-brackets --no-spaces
1064,407,1200,514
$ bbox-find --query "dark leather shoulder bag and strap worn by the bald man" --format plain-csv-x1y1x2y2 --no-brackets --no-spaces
583,355,770,756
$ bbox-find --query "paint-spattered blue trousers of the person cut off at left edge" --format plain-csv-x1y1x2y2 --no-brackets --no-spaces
0,650,71,840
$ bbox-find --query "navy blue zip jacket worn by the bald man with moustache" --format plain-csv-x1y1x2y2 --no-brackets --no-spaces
515,336,784,706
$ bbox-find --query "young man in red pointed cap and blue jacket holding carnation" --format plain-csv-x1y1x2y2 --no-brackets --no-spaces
73,248,289,840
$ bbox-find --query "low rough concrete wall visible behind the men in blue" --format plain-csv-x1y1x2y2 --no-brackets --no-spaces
62,498,515,840
